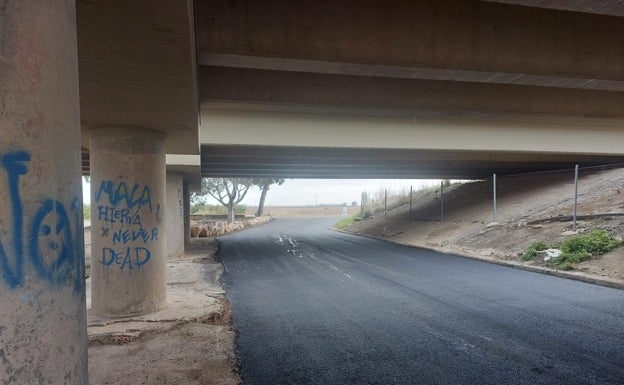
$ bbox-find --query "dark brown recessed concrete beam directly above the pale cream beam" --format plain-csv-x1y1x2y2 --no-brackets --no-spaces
200,67,624,118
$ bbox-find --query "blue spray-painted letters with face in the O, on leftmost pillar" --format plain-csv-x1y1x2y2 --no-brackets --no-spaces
0,151,84,293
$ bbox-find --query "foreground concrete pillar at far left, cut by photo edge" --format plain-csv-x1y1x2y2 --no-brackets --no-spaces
0,0,88,385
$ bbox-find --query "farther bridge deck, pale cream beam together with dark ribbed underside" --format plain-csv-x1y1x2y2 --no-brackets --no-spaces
201,104,624,179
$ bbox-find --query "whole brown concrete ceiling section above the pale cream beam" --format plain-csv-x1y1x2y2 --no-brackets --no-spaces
195,0,624,117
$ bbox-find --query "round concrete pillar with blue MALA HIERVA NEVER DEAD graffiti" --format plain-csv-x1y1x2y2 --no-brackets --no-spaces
90,127,167,317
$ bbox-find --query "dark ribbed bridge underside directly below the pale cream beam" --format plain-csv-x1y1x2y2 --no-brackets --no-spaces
201,145,622,179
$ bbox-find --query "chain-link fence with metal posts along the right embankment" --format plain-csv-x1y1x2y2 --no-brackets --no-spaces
362,164,624,225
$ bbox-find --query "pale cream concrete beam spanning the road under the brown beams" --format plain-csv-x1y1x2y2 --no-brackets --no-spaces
201,106,624,156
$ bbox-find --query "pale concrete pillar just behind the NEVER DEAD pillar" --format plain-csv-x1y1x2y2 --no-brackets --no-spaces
165,171,184,257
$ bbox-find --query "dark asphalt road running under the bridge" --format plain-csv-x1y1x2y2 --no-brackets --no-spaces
218,219,624,385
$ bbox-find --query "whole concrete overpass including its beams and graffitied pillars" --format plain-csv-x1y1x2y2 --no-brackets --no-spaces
0,0,624,383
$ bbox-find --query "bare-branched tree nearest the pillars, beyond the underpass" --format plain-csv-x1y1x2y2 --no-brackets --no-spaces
191,178,254,223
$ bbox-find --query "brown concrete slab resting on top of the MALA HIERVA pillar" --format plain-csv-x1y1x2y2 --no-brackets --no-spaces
76,0,199,154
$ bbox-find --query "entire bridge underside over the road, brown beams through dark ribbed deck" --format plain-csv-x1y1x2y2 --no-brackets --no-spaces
194,0,624,179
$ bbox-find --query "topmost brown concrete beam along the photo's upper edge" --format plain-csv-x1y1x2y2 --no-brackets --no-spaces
195,0,624,86
